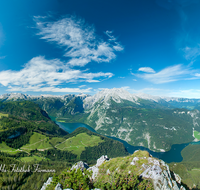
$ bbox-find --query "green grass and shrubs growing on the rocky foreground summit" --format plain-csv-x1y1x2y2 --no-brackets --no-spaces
47,151,153,190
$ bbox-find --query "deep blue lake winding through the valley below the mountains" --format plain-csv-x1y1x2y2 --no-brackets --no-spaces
52,118,200,163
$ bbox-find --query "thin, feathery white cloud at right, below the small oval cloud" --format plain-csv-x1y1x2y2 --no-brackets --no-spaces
134,64,198,84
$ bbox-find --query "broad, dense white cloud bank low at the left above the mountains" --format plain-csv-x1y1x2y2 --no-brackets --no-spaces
0,56,113,92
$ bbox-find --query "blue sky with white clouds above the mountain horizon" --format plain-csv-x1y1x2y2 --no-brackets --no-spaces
0,0,200,98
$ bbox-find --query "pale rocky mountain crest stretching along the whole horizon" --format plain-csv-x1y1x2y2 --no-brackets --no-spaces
0,88,200,108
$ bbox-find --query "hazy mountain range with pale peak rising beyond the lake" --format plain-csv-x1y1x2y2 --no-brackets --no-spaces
1,89,200,151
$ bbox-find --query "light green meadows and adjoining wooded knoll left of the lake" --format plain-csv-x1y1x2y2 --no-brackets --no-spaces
1,128,128,165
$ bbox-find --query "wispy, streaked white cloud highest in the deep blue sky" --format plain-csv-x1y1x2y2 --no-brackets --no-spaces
34,17,123,66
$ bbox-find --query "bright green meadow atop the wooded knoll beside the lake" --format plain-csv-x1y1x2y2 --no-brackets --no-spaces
55,133,104,156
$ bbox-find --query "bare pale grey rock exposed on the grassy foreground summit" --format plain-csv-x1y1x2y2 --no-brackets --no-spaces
41,155,185,190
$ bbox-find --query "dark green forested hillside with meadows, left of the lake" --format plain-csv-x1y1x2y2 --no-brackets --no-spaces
0,101,129,190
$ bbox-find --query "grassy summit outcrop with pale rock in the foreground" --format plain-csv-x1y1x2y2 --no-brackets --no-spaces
43,151,185,190
